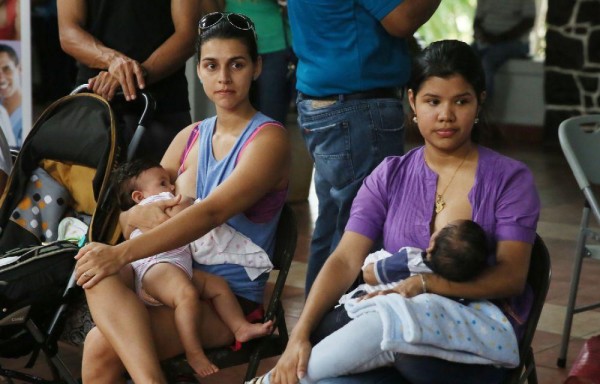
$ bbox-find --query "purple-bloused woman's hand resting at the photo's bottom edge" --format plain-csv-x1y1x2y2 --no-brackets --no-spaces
270,338,312,384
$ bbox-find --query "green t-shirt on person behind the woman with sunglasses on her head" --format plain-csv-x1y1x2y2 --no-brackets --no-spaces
225,0,292,54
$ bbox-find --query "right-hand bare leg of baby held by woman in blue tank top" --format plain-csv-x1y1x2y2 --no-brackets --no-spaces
195,272,273,342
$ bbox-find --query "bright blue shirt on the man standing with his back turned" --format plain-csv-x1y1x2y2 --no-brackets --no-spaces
287,0,410,96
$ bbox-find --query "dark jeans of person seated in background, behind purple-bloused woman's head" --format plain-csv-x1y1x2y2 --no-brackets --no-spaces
473,40,529,97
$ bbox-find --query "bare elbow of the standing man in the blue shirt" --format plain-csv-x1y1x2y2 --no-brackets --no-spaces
381,0,441,37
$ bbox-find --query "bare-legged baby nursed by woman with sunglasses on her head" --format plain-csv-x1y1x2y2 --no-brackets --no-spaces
113,160,273,377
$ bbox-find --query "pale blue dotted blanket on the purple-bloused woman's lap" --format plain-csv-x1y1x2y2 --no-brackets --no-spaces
345,294,519,368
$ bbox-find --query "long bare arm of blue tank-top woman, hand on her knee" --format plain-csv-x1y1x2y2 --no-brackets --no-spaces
76,125,290,288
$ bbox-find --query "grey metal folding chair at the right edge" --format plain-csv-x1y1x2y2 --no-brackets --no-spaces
556,115,600,367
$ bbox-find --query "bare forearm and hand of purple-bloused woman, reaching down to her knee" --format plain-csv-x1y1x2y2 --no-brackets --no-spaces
271,232,373,384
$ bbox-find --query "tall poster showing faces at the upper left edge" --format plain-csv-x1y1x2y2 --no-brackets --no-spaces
0,0,31,148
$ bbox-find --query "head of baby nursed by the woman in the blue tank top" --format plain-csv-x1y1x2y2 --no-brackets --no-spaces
112,159,175,211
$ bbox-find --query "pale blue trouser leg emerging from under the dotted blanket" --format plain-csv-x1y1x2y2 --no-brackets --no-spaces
301,312,394,383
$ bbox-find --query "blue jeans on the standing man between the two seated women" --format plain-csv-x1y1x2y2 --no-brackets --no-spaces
292,93,404,294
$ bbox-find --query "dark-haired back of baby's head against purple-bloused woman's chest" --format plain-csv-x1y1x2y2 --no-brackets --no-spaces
425,220,488,281
